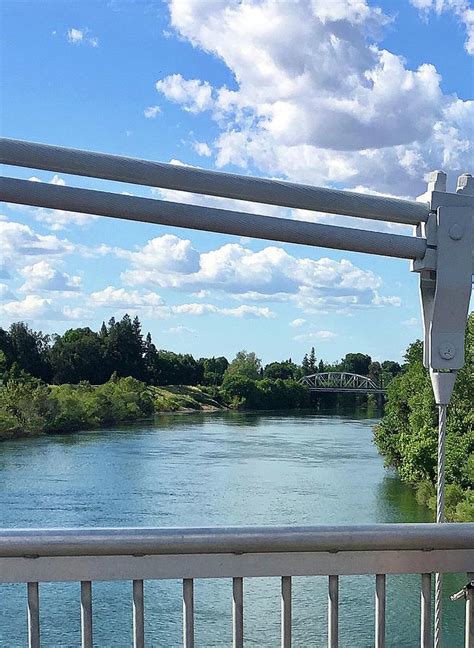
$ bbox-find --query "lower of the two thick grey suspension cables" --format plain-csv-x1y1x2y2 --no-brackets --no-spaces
0,178,427,259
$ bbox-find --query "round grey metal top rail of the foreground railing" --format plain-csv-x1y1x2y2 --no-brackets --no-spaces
0,523,474,556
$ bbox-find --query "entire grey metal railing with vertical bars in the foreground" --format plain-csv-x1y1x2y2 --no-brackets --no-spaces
0,524,474,648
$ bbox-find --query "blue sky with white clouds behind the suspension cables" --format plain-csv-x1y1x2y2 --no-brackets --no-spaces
0,0,474,362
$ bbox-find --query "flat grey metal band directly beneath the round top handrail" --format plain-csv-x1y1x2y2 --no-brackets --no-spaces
0,548,474,583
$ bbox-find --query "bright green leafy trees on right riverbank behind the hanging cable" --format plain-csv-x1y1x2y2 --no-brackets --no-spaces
375,313,474,521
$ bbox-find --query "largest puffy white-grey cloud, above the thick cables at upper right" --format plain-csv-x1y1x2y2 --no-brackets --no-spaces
162,0,474,196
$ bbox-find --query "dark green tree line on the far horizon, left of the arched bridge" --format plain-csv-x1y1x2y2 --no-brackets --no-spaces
0,315,401,386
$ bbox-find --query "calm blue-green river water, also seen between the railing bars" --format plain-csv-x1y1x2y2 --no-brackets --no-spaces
0,413,464,648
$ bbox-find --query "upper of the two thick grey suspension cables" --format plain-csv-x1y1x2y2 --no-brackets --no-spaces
0,138,430,225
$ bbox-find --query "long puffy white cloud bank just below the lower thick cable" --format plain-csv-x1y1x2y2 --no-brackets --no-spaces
118,235,400,312
